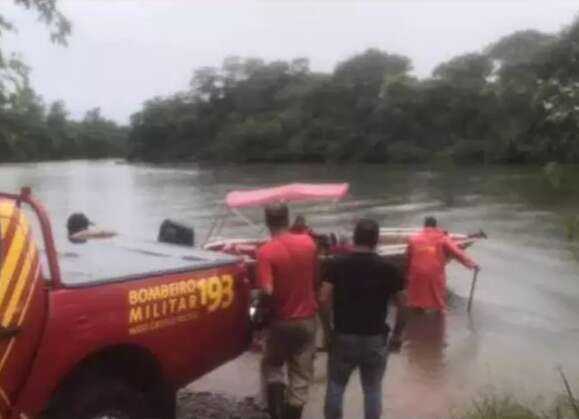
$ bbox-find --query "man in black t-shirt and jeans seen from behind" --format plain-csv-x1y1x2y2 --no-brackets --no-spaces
320,219,404,419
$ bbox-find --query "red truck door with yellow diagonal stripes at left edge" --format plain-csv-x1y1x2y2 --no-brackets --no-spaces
0,200,46,419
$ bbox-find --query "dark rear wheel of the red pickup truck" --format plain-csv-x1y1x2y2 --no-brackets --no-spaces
45,379,164,419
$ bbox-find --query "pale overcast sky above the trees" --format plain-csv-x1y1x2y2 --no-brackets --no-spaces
0,0,579,122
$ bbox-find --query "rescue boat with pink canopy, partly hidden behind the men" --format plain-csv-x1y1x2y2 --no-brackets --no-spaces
203,183,486,264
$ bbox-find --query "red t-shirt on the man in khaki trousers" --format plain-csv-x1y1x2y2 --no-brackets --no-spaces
257,232,318,320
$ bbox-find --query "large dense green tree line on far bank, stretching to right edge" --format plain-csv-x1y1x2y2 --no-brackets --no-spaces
128,13,579,163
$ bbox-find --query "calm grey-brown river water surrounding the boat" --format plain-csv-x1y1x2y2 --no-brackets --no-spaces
0,161,579,418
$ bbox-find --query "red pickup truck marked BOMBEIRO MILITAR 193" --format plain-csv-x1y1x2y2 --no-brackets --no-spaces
0,189,251,419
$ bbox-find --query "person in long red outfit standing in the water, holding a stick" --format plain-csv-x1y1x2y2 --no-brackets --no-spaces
406,216,480,312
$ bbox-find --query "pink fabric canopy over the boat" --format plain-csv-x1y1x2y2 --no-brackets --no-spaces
225,183,349,208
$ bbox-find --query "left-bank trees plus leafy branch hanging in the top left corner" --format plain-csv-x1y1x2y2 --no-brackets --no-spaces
0,0,128,162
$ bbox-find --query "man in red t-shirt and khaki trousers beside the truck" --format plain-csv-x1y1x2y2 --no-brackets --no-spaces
257,204,318,419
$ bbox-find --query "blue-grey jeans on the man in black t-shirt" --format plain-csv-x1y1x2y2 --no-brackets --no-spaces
324,334,388,419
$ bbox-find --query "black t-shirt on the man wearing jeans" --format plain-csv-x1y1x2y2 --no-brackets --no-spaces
324,252,404,335
